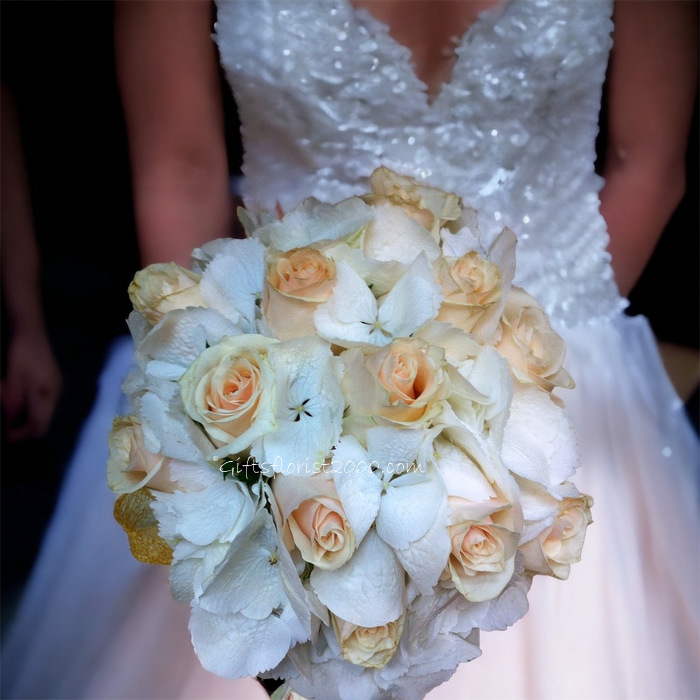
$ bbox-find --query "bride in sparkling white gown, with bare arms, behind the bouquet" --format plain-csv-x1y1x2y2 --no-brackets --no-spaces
4,0,700,700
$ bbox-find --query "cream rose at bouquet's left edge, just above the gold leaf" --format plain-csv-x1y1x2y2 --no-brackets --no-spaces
107,416,174,493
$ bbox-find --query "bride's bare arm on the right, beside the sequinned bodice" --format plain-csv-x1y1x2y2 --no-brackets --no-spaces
601,0,698,296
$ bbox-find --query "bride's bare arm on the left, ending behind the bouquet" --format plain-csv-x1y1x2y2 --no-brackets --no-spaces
114,0,232,265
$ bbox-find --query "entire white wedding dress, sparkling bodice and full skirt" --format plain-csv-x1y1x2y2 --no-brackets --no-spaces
3,0,700,700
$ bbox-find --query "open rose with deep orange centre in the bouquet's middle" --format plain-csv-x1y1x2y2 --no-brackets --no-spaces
341,338,450,423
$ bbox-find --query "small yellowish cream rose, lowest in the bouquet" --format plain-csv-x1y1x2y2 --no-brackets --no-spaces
331,615,404,668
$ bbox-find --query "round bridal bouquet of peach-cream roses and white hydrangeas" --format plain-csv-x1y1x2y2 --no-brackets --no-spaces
108,168,591,700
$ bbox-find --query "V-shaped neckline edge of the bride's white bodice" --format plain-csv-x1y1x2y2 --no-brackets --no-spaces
344,0,515,109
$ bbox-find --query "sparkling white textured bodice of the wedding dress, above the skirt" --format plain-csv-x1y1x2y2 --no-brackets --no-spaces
215,0,624,326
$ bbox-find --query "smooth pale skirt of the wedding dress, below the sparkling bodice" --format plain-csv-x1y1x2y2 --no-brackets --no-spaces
2,316,700,700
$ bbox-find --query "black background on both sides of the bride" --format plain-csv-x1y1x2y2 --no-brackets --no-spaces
0,0,700,640
